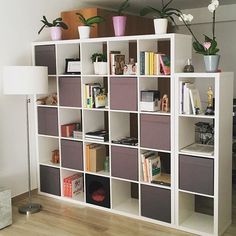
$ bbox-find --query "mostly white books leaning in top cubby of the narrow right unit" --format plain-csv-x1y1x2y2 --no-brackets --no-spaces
179,81,202,115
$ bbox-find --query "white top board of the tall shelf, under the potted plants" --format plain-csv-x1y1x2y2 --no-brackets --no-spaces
32,33,192,45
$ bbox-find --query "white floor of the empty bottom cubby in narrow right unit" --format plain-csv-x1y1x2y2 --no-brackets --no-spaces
180,213,214,235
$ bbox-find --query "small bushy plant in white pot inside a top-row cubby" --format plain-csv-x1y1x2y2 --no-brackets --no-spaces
91,53,107,75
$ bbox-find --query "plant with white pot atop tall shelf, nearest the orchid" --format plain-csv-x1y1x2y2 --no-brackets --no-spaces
140,0,181,34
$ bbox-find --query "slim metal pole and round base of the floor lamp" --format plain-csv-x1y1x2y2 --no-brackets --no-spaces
19,95,42,215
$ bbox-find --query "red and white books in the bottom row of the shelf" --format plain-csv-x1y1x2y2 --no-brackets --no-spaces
63,174,83,198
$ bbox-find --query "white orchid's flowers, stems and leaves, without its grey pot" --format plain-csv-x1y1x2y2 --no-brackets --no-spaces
179,0,219,55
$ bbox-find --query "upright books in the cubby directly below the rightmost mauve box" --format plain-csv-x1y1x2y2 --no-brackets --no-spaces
141,151,161,183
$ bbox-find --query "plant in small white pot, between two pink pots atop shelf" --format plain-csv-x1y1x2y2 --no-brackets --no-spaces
76,12,104,39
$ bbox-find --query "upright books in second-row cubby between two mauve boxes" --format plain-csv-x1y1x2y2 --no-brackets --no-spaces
84,83,107,108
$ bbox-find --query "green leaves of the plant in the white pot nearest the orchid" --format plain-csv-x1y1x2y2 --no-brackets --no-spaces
140,0,181,25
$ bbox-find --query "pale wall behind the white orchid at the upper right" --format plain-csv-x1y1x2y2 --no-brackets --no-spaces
178,4,236,97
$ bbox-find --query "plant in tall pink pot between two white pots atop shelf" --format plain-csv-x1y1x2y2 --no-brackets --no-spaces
112,0,129,36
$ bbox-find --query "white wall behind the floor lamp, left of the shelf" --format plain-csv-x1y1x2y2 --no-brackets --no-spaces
0,0,88,196
